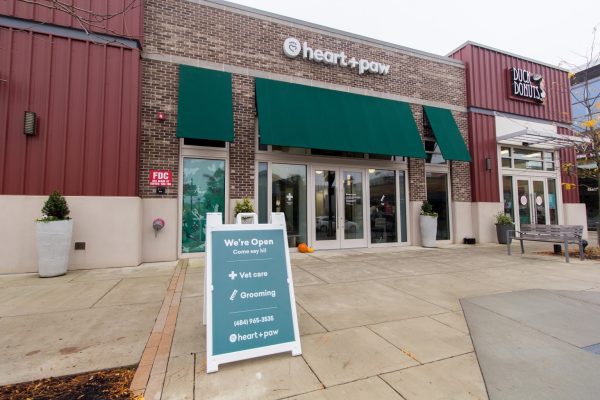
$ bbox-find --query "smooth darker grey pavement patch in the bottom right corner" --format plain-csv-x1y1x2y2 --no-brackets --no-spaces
461,289,600,400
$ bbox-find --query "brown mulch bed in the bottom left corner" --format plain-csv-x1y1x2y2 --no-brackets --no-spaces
0,368,143,400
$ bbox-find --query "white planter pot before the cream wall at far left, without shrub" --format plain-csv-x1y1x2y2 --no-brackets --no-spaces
35,219,73,278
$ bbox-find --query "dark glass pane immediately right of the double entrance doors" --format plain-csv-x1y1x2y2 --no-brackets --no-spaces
369,169,398,243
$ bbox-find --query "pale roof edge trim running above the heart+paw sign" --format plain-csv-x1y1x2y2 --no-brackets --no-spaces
191,0,464,68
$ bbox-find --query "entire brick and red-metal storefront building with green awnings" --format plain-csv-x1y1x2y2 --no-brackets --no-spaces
0,0,585,273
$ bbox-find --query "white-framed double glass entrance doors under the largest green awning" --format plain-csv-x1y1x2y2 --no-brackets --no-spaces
313,166,367,249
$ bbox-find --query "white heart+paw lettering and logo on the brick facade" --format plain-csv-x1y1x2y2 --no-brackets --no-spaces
283,38,390,75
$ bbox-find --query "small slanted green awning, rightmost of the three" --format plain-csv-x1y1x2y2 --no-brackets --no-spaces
423,106,471,161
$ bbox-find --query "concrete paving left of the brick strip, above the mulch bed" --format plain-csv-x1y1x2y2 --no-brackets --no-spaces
0,262,177,385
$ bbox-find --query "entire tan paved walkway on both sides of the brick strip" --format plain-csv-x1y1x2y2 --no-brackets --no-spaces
0,239,600,400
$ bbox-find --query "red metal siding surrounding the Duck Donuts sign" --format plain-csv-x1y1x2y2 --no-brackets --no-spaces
451,44,571,123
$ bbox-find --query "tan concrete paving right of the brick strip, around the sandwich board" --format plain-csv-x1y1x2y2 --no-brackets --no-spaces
152,244,600,400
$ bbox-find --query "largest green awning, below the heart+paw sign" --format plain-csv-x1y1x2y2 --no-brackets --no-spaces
256,78,426,158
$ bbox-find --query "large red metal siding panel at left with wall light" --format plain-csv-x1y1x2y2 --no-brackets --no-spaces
0,28,140,196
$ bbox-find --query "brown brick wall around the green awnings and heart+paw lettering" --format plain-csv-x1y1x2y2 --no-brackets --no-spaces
140,0,470,201
